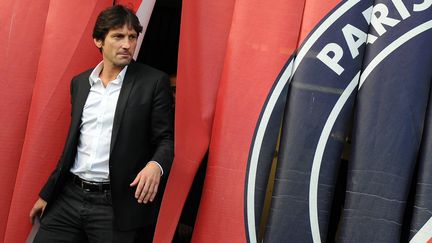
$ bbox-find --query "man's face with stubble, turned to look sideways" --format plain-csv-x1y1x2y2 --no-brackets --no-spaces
94,25,138,68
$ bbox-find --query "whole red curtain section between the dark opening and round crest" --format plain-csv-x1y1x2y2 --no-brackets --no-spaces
155,0,335,242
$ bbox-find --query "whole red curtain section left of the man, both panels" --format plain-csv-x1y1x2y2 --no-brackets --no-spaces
0,0,112,242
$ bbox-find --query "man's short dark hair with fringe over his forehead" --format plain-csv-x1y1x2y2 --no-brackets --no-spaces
93,5,143,41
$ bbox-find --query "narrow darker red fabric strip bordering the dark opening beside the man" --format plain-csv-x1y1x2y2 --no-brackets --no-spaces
154,0,234,243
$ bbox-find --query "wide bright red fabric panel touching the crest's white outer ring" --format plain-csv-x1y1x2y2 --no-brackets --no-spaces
193,0,304,242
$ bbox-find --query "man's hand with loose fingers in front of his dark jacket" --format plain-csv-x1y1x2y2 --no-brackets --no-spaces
130,162,161,203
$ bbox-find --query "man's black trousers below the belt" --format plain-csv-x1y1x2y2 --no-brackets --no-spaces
33,179,155,243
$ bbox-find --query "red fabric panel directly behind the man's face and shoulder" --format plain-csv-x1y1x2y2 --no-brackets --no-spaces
4,0,112,242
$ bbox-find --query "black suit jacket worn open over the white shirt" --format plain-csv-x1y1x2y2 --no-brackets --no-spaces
39,62,174,230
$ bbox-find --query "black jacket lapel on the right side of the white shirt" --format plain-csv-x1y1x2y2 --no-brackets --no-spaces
110,63,136,153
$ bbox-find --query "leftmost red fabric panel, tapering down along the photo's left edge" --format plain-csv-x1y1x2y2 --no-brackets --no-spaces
0,0,49,241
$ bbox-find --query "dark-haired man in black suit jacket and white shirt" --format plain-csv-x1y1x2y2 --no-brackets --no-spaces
30,5,174,243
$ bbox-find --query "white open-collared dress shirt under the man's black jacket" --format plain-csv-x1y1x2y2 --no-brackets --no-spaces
70,62,127,182
